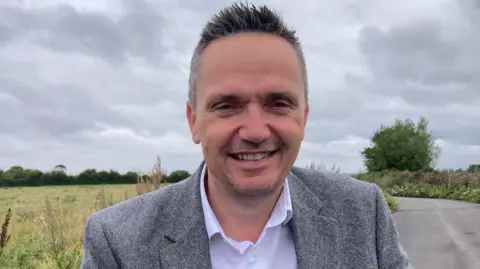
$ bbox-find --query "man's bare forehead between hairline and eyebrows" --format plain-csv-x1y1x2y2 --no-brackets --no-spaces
197,33,303,100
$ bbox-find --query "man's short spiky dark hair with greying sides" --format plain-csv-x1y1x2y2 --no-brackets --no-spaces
188,3,308,109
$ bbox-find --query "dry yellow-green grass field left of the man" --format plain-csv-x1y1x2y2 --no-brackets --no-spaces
0,184,141,269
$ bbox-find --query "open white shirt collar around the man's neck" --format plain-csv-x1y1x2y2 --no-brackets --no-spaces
200,164,293,238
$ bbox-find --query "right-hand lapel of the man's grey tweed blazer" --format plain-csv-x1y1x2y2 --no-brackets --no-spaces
288,173,339,269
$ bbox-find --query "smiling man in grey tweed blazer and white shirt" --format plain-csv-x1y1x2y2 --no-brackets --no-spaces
81,4,411,269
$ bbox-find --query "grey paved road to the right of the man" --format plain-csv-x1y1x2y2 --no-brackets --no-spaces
393,197,480,269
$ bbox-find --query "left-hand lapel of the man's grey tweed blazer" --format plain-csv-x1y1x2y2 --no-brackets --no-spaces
160,162,212,269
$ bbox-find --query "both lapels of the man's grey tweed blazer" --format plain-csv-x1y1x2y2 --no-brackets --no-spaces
160,161,338,269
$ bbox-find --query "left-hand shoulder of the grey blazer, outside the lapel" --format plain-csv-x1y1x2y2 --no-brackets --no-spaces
84,177,202,268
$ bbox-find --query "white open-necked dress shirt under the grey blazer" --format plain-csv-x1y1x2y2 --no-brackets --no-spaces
200,165,297,269
